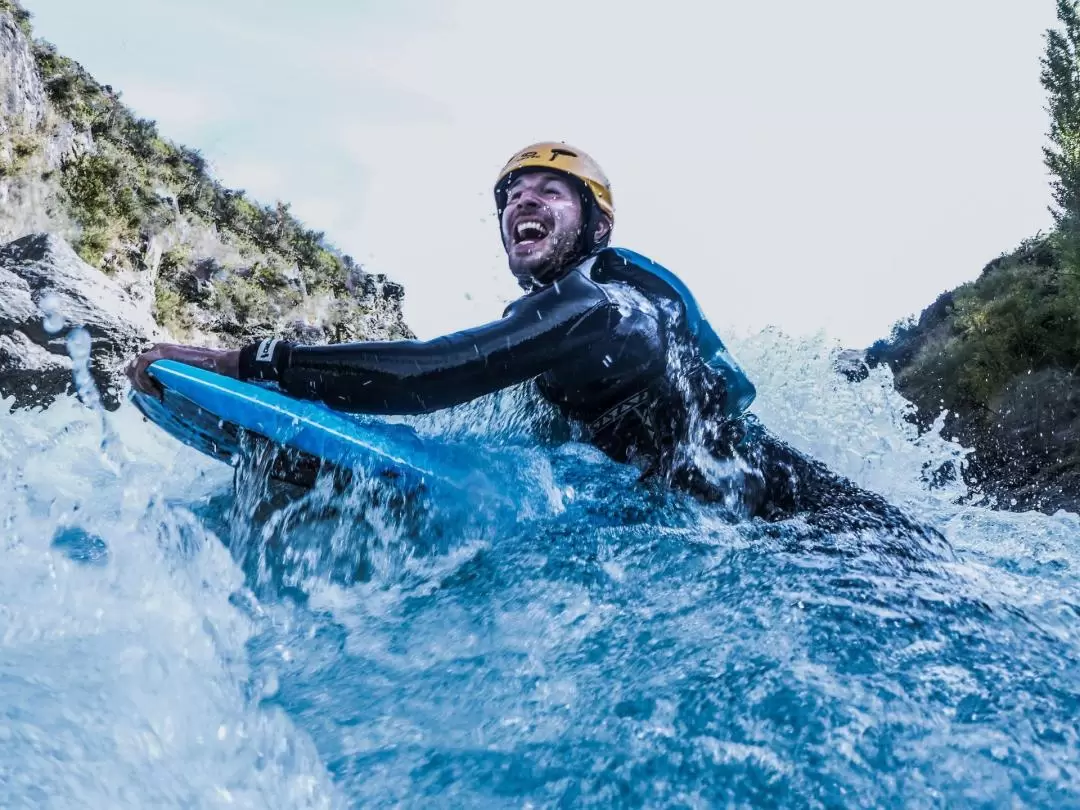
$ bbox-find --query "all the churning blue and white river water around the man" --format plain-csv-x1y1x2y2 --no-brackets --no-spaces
0,332,1080,808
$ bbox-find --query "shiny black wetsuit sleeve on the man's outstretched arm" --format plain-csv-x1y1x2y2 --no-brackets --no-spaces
240,284,619,414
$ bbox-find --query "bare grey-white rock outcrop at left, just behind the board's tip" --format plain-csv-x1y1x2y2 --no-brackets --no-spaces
0,233,160,407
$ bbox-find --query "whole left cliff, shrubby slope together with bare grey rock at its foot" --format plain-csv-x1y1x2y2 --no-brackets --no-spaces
0,0,411,405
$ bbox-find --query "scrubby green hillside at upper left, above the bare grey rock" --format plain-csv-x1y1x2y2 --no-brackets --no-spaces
0,0,410,345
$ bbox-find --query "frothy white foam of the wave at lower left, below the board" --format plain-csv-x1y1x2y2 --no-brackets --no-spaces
0,390,335,808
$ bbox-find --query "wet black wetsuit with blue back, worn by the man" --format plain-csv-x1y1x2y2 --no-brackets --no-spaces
241,248,937,540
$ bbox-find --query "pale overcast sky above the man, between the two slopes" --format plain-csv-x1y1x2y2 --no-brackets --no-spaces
25,0,1054,346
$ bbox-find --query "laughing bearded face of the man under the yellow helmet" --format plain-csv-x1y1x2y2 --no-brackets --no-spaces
501,172,584,285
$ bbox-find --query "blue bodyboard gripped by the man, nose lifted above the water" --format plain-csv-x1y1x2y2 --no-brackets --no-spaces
131,360,483,490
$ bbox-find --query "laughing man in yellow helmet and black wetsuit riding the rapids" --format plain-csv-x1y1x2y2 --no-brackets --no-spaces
129,143,933,536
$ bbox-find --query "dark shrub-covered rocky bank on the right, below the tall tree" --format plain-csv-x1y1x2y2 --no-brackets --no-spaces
846,234,1080,512
